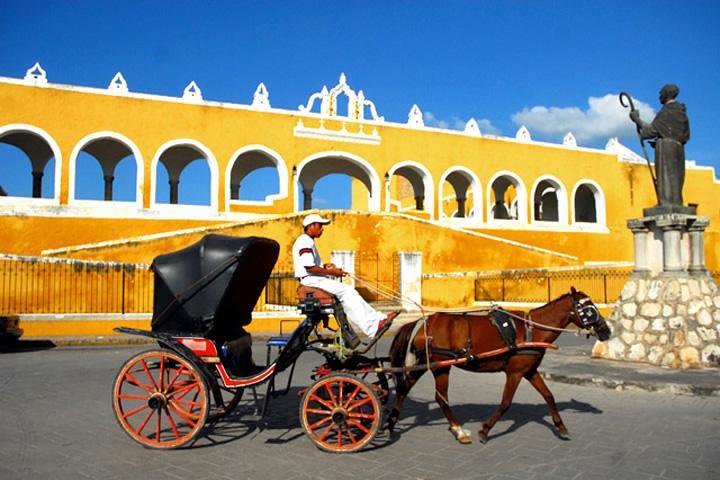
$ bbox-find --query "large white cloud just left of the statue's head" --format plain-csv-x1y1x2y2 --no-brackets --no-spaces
512,93,655,144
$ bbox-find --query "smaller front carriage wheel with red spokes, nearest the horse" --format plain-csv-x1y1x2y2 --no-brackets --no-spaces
300,375,382,453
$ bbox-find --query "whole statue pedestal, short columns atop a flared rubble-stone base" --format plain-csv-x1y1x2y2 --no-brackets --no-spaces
593,212,720,369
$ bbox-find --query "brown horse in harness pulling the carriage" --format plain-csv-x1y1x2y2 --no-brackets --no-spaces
386,288,610,443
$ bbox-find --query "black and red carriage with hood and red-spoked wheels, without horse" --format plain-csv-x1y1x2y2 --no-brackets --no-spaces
113,235,389,452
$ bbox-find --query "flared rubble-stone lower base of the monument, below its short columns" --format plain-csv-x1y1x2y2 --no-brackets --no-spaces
592,275,720,369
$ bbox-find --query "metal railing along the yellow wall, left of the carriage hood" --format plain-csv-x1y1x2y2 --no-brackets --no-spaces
0,255,153,314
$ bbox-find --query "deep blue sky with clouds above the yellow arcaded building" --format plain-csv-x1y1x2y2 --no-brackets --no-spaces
0,0,720,207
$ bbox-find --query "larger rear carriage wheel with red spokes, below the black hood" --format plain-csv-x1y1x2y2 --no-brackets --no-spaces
113,350,210,448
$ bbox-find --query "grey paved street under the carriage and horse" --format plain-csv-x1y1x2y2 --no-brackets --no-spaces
0,343,720,480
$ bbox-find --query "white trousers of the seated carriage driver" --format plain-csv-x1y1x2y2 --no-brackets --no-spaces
300,275,385,337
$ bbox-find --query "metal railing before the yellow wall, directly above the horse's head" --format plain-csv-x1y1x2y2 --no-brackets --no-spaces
475,267,632,303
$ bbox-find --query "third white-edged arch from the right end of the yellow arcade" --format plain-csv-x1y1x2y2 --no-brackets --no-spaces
487,170,527,223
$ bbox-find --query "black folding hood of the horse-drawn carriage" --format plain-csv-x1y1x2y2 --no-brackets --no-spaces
151,234,280,340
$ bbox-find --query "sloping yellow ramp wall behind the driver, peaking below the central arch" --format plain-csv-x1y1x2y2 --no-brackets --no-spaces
43,211,575,272
